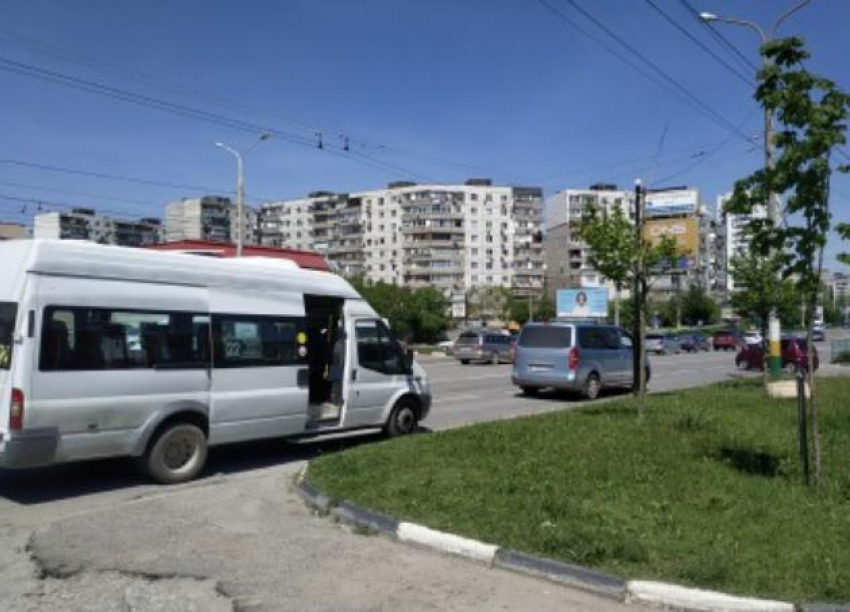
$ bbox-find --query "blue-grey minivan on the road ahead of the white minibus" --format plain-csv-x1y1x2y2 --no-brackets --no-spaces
511,323,650,399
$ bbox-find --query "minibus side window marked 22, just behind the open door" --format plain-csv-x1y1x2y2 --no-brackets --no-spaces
212,314,307,368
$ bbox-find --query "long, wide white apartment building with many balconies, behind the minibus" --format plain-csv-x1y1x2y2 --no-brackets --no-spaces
260,179,544,297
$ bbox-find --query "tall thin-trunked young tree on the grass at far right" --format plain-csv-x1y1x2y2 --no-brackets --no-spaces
727,37,850,483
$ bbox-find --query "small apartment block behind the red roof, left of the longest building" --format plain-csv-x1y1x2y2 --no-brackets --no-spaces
165,196,259,244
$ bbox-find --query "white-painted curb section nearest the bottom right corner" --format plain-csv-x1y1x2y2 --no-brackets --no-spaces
626,580,794,612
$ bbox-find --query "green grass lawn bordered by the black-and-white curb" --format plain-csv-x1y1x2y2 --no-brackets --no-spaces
308,378,850,601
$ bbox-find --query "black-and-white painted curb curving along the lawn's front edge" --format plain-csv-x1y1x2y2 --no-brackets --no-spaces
296,464,824,612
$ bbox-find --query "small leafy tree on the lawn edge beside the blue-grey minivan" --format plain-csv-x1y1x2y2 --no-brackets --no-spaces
578,201,676,419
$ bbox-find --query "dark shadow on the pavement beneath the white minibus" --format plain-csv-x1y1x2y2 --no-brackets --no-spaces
0,428,398,505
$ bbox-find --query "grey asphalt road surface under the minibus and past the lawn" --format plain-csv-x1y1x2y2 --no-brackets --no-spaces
0,334,840,612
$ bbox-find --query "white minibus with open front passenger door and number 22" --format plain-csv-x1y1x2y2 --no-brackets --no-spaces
0,240,424,483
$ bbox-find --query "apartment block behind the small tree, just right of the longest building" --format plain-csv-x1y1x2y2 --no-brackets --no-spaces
544,183,635,299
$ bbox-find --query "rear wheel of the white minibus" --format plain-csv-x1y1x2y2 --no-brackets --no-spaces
139,423,207,484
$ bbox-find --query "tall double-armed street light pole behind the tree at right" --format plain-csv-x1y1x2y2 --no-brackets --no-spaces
699,0,812,377
